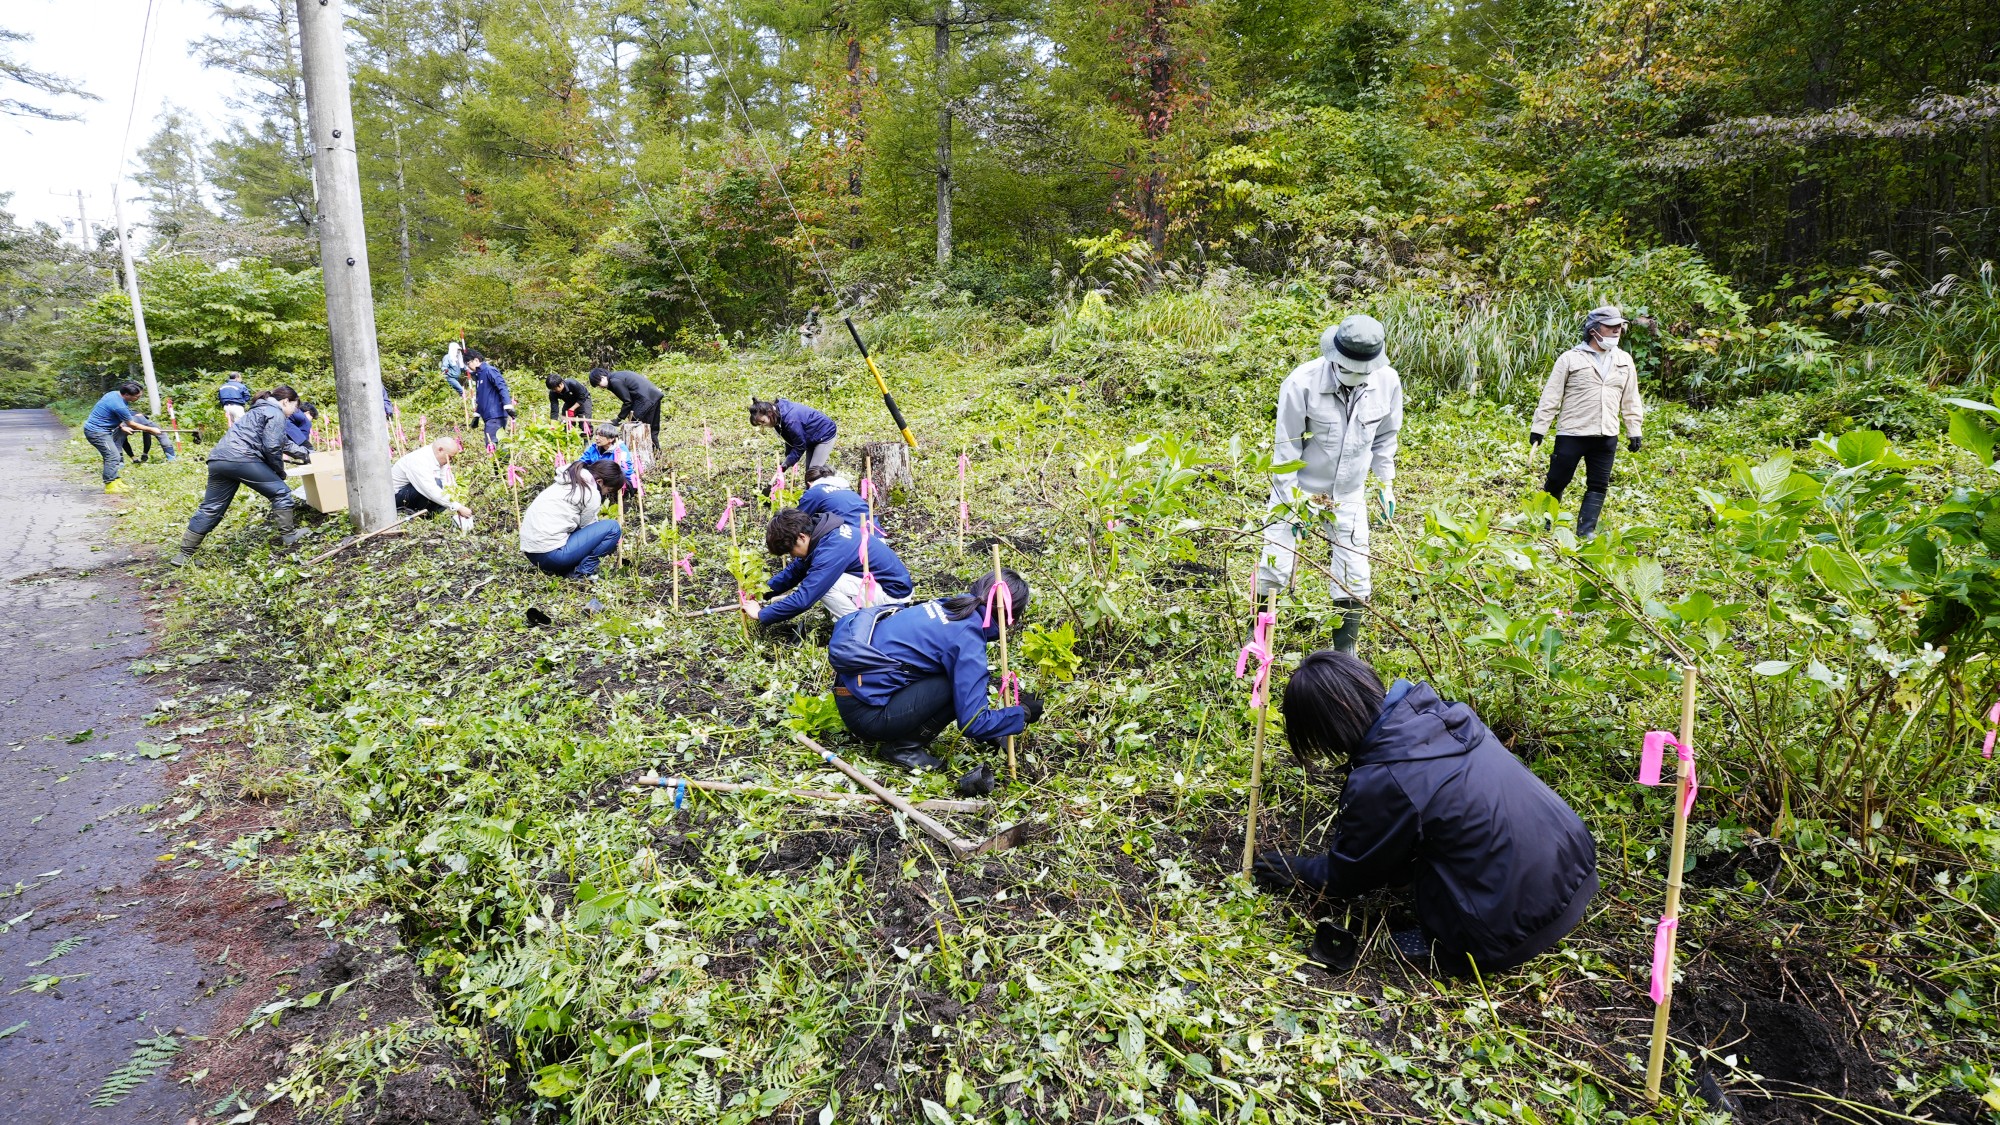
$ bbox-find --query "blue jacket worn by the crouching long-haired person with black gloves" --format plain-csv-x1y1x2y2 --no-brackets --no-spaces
828,601,1028,743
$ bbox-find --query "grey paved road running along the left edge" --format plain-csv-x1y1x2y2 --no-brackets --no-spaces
0,410,216,1125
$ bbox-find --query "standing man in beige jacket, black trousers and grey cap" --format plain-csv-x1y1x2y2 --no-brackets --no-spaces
1528,304,1646,542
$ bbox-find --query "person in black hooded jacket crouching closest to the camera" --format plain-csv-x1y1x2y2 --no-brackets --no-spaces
1254,649,1598,973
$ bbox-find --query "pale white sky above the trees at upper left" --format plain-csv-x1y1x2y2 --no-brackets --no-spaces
0,0,238,236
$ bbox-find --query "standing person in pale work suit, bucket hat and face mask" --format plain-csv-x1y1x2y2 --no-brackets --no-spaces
1256,316,1402,653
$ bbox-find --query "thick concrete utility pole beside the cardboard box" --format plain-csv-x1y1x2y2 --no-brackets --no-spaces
298,0,396,534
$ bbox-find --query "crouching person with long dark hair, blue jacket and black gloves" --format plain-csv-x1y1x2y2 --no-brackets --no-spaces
826,571,1042,777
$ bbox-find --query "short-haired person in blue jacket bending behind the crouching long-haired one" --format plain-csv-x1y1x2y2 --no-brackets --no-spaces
744,508,914,625
